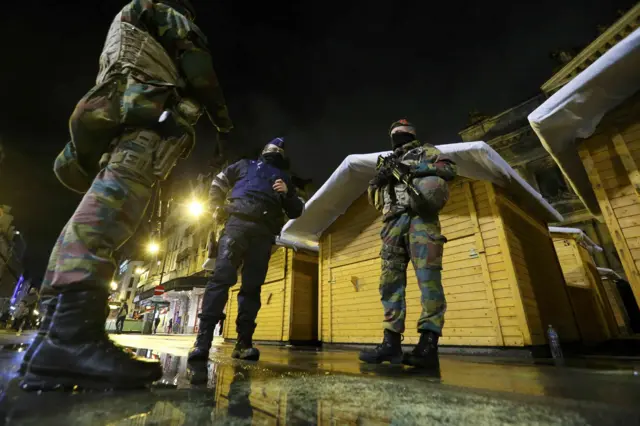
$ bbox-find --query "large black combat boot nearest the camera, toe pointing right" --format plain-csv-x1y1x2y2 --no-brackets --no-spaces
21,288,162,390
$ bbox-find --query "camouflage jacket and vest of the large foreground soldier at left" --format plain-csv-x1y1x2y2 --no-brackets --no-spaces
60,0,233,192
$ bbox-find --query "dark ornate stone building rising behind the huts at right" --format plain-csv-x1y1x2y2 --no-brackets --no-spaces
459,4,640,273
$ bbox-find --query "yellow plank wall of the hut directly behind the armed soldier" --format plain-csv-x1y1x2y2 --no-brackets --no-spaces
319,179,572,346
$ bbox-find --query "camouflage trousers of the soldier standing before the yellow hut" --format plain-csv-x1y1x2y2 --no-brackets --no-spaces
380,213,447,334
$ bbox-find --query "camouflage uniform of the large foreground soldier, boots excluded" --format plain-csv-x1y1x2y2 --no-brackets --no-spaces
43,0,233,287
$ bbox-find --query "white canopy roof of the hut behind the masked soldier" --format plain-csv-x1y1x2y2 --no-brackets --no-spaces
281,142,562,247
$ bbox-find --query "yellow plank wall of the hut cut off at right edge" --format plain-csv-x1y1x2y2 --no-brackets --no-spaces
579,95,640,310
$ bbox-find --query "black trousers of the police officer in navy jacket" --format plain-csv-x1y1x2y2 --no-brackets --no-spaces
199,216,274,337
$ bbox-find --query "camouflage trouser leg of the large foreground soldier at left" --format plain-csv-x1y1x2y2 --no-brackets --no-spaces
42,131,160,293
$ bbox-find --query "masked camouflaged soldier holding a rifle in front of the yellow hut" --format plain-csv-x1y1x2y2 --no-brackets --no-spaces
360,120,456,368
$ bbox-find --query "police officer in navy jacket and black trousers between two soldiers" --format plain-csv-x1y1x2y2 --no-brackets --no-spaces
189,138,304,361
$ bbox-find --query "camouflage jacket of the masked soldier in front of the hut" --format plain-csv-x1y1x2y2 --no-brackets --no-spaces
367,140,457,221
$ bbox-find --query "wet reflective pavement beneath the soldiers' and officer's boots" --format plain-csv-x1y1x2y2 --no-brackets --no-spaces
0,333,640,426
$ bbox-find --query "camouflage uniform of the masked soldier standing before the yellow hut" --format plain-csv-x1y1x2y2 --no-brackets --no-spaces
368,140,456,334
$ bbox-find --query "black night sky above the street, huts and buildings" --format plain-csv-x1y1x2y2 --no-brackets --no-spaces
0,0,635,280
